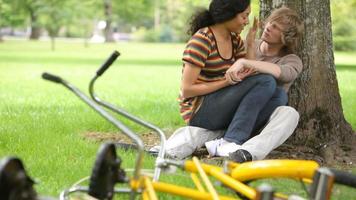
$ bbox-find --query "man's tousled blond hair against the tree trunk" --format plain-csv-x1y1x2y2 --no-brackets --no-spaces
265,6,304,53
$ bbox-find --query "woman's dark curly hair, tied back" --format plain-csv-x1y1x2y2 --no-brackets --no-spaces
188,0,250,35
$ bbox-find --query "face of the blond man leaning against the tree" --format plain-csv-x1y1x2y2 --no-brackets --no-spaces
261,21,283,44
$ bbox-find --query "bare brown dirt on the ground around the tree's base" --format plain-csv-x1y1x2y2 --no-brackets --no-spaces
83,132,356,169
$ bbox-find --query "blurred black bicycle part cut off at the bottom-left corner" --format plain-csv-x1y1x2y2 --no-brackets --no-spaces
0,157,37,200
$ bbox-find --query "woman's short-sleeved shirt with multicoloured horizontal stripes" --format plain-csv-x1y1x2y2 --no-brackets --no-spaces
178,27,246,123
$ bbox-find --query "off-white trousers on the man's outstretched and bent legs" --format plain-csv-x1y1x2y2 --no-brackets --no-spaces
152,106,299,160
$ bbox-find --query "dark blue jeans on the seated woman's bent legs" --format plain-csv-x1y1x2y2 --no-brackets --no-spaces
189,74,276,144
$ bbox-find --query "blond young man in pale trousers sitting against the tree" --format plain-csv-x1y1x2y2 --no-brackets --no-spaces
150,7,303,162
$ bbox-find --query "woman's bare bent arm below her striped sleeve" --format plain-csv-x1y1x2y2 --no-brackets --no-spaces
181,63,230,98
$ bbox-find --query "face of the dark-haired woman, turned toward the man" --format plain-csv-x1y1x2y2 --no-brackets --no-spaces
226,6,251,34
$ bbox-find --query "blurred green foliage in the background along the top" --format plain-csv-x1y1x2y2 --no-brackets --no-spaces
0,0,356,50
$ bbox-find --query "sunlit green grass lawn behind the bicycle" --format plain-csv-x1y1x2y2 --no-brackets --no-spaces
0,40,356,199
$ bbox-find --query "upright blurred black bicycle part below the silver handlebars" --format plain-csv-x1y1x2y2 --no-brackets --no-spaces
88,143,127,199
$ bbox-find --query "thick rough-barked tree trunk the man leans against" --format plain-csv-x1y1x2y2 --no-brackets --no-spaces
260,0,355,163
